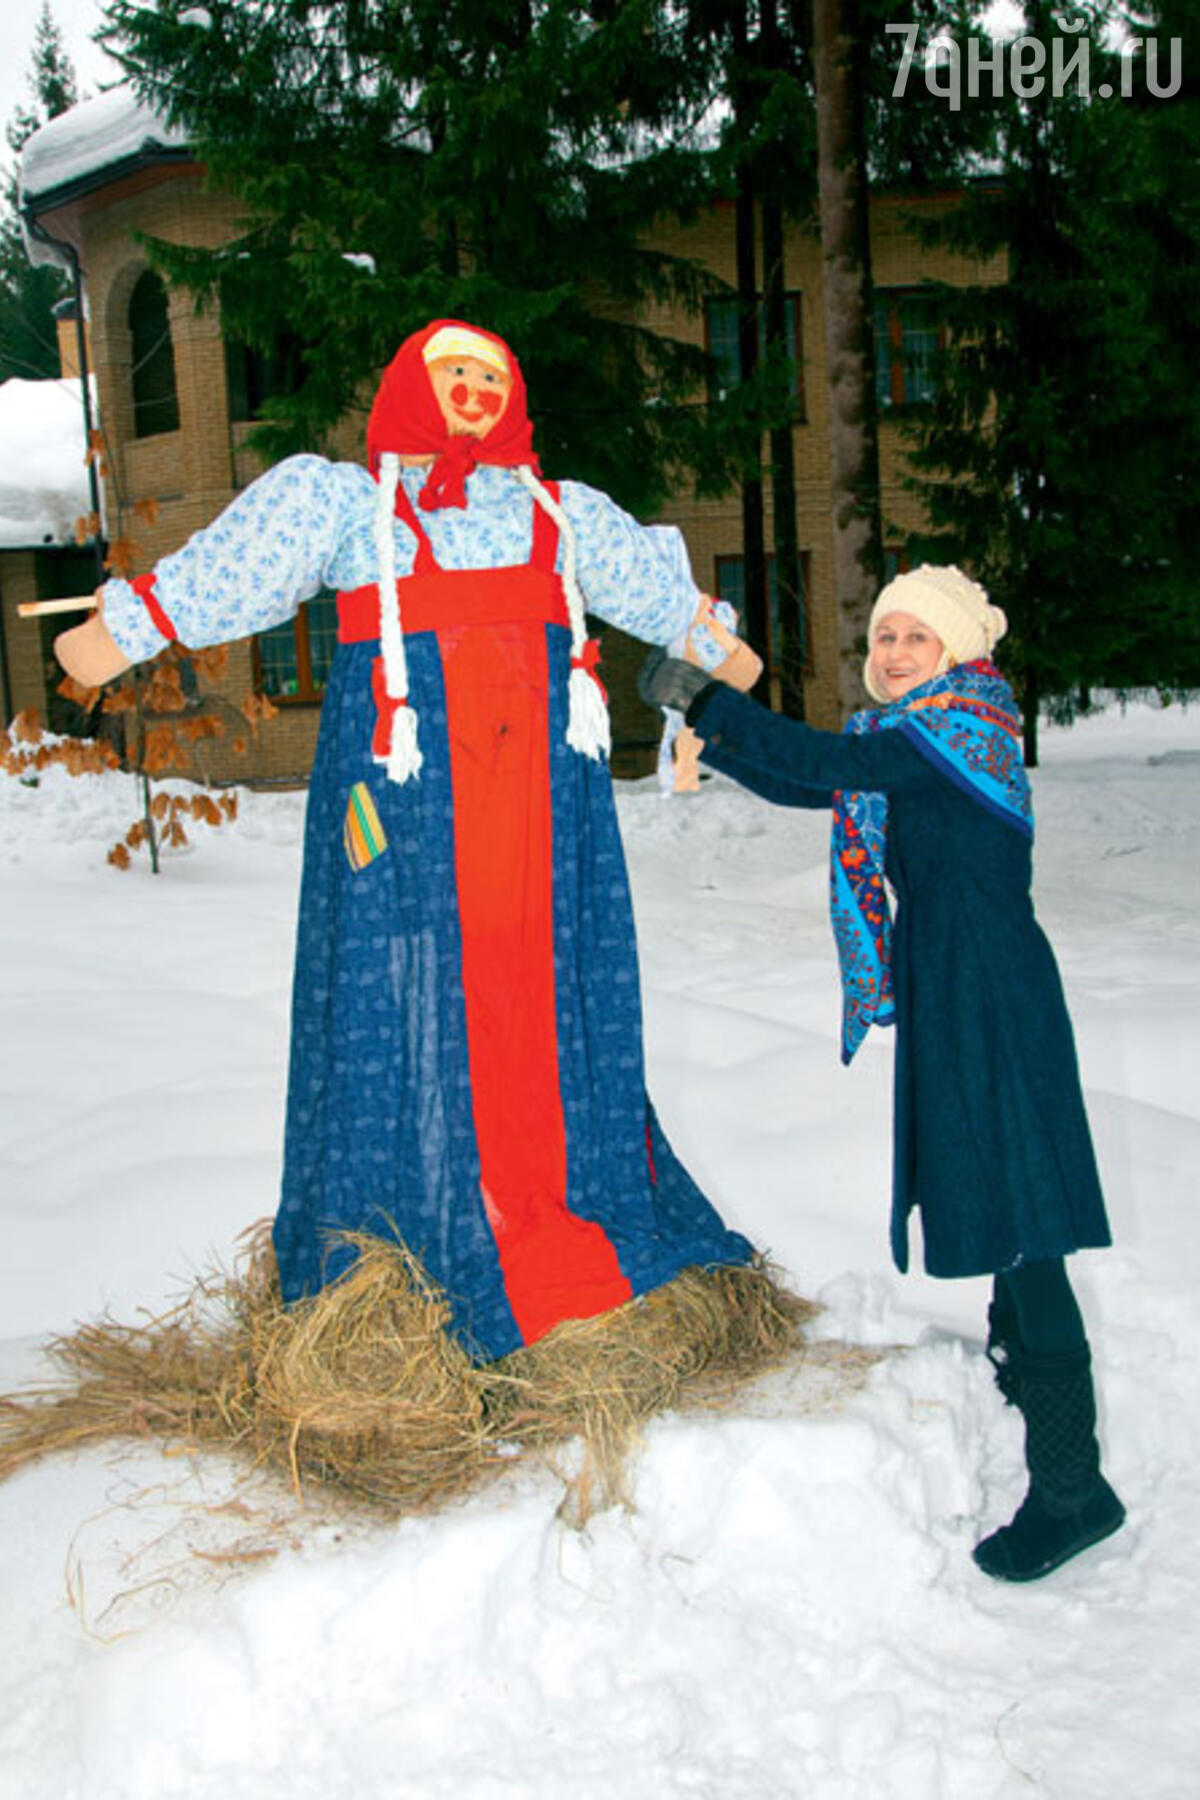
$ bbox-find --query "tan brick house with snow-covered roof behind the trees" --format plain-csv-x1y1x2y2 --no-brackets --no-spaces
9,90,1004,779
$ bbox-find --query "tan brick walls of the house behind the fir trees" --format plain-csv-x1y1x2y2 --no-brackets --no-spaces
28,164,1004,779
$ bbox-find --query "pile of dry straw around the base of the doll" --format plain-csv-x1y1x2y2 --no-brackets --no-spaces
0,1228,827,1525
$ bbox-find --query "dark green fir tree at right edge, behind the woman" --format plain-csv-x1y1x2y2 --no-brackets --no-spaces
892,4,1200,763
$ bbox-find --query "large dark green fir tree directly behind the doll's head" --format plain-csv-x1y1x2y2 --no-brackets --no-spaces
106,0,755,513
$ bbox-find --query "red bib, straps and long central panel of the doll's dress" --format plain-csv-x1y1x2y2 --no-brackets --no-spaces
338,484,631,1343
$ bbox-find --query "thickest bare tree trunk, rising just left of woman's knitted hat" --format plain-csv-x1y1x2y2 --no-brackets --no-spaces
813,0,883,718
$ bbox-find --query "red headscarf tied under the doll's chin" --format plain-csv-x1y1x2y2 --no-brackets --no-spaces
367,319,538,511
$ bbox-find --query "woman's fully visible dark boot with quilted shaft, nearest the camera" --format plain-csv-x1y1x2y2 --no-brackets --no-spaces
975,1346,1124,1580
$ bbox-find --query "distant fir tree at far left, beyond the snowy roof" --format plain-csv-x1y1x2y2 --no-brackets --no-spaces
0,0,77,382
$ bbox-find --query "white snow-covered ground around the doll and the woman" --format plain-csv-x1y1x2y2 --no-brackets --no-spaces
0,707,1200,1800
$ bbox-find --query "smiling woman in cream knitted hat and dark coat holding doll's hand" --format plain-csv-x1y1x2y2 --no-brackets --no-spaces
640,565,1124,1580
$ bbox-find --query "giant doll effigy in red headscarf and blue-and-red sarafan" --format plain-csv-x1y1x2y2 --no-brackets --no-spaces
58,319,752,1361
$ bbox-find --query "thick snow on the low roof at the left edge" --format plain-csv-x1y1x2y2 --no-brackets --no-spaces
0,380,92,551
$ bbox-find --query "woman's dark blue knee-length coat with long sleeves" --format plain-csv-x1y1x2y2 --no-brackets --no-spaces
689,684,1112,1276
